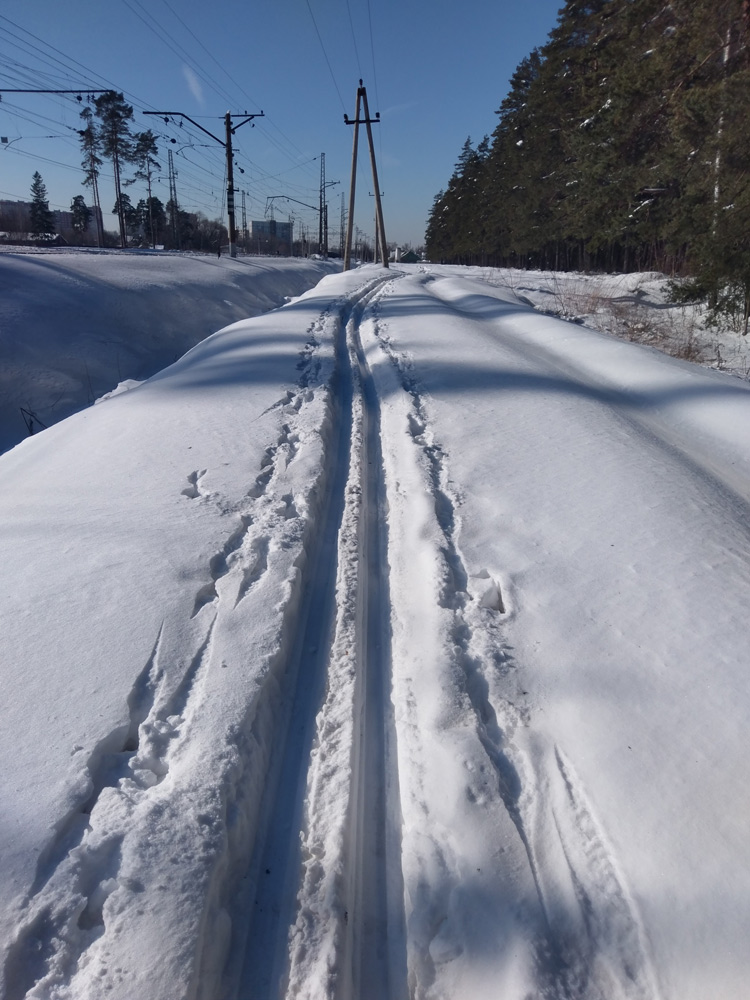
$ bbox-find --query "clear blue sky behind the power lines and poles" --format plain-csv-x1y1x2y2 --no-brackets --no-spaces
0,0,562,245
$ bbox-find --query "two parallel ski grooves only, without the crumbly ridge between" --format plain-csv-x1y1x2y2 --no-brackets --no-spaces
222,279,405,1000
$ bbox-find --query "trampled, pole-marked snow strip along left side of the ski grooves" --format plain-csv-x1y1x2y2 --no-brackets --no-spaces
0,282,346,1000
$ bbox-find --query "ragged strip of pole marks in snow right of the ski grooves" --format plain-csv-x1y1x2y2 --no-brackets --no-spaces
373,284,658,1000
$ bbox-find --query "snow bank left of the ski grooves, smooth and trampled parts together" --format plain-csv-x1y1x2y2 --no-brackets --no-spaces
0,268,361,1000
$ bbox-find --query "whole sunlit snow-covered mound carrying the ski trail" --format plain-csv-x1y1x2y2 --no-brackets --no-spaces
0,265,750,1000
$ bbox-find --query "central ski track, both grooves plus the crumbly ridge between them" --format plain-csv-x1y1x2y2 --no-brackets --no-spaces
222,279,403,998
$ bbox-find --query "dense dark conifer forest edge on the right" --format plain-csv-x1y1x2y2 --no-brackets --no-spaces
426,0,750,317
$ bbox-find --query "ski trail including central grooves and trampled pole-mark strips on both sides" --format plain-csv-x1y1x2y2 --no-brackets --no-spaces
2,277,658,1000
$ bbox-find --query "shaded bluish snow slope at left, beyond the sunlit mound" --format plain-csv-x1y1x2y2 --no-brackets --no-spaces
0,247,338,452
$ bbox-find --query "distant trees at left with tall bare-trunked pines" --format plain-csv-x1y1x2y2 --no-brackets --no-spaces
0,90,227,250
